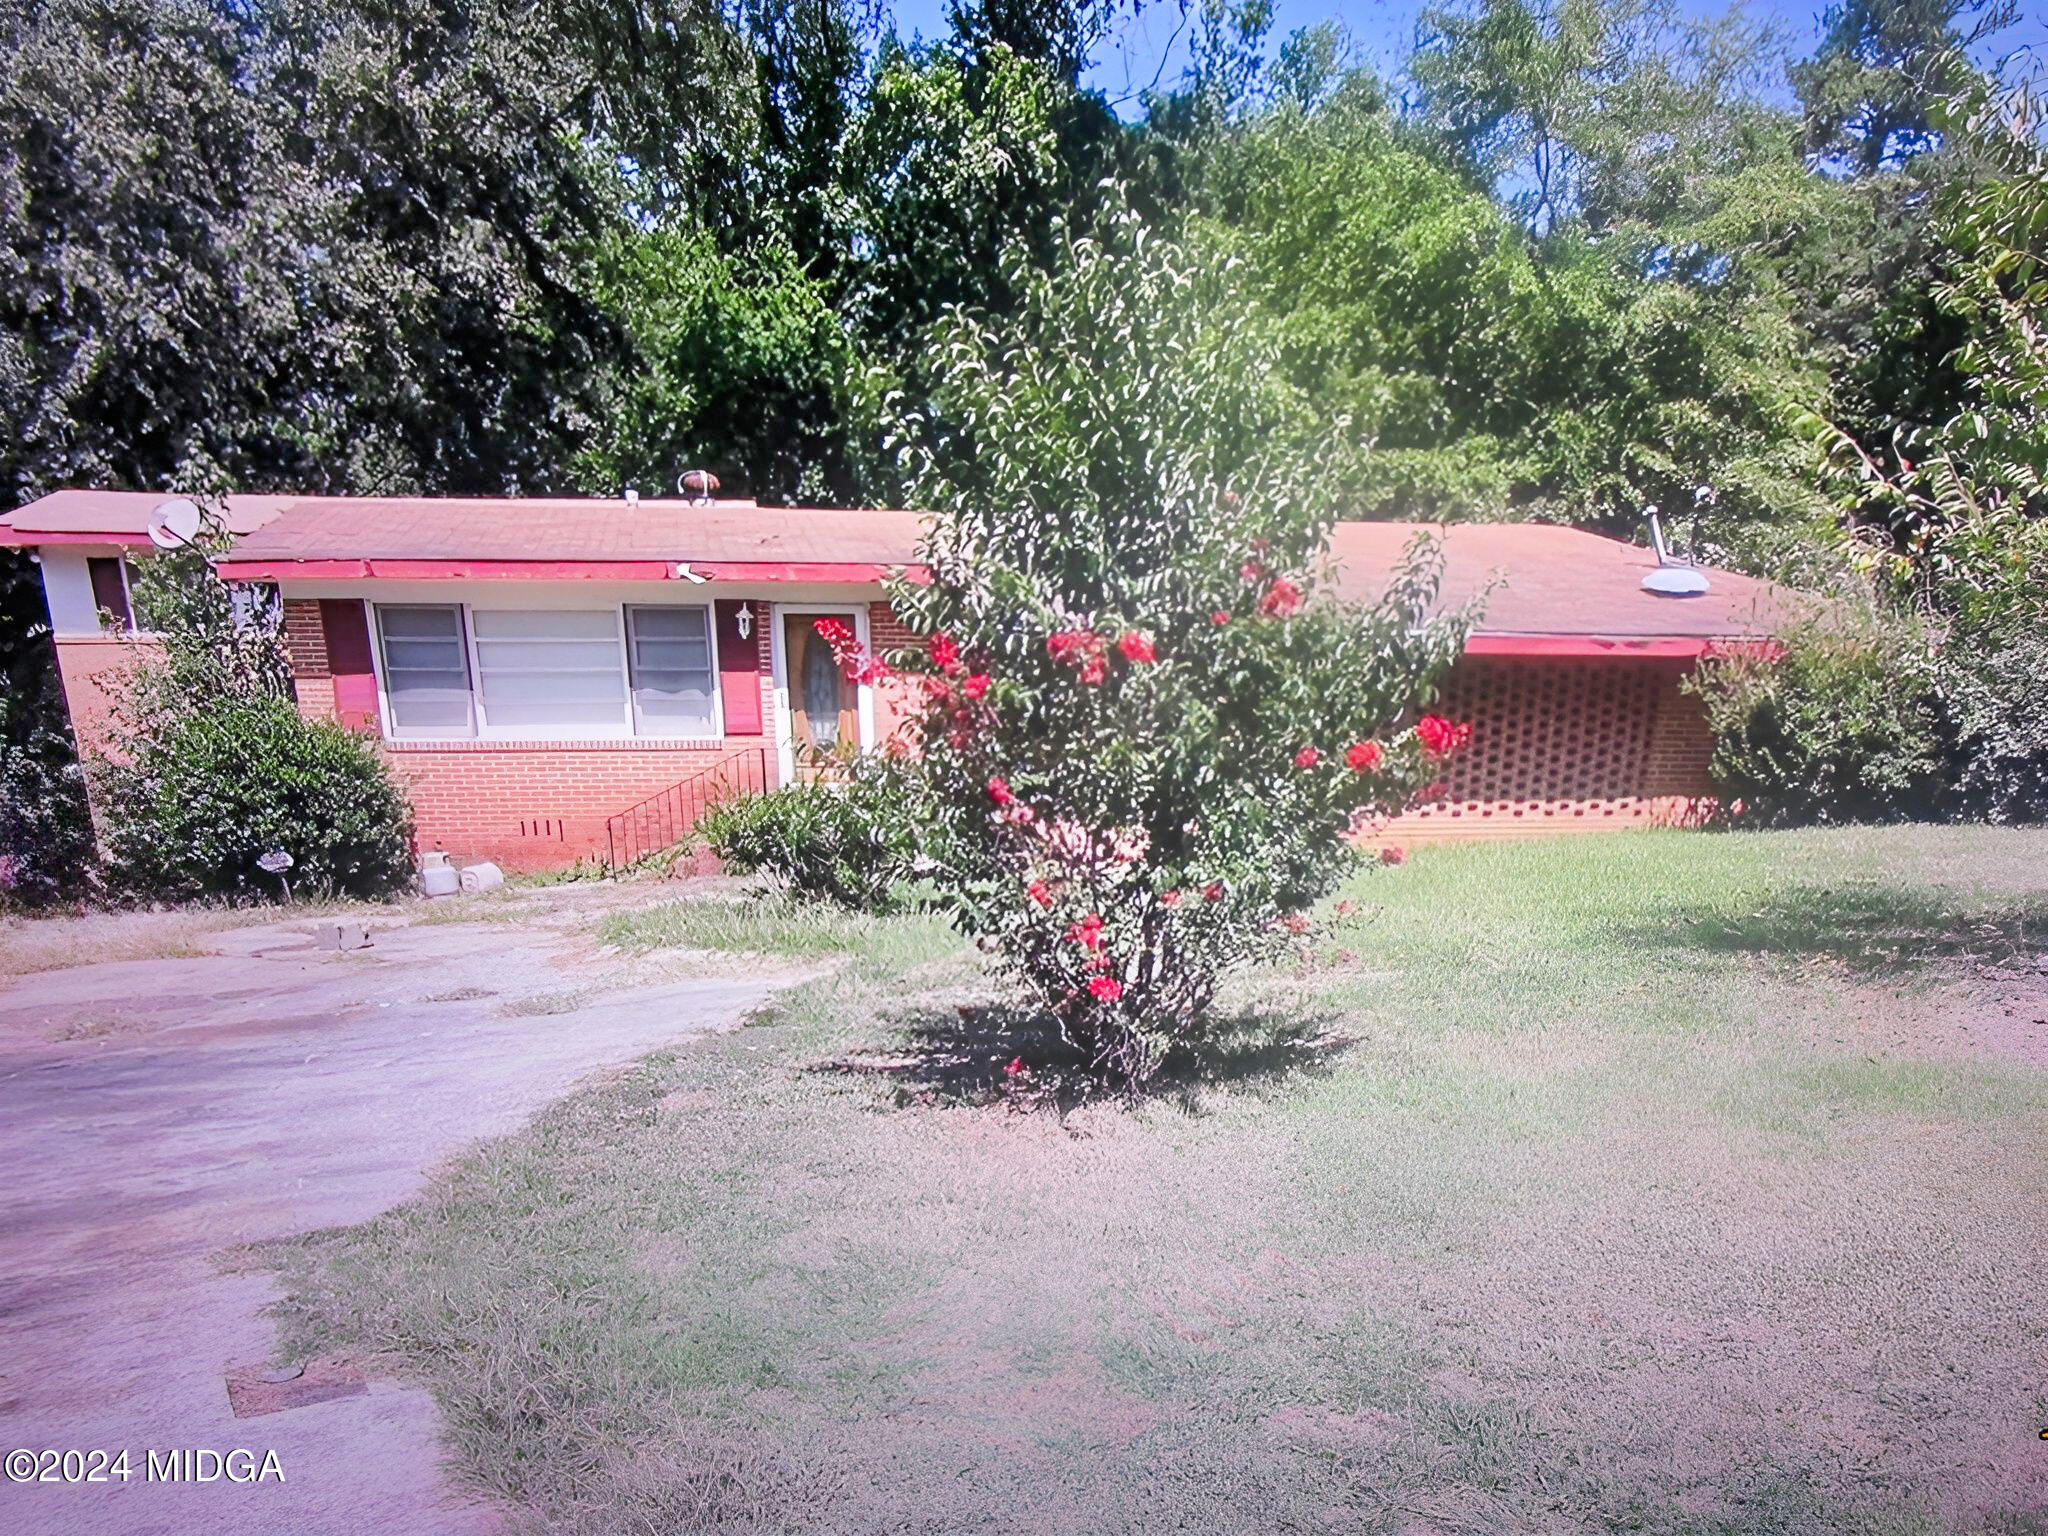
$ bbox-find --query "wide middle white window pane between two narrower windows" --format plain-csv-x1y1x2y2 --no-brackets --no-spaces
469,608,627,735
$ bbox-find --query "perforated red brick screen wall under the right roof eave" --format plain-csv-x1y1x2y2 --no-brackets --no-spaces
1384,657,1712,842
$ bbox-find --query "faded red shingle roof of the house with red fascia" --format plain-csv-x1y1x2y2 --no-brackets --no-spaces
0,492,1794,653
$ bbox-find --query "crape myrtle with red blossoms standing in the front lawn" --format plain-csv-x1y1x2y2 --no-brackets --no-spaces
856,215,1470,1087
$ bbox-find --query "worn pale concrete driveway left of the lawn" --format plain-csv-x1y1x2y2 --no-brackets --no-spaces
0,903,772,1536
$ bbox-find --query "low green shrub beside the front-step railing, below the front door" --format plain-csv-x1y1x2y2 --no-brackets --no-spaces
698,758,915,911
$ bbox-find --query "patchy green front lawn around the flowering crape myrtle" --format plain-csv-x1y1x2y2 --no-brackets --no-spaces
268,827,2048,1534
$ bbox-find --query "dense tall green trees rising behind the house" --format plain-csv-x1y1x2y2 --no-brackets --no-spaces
0,0,2044,872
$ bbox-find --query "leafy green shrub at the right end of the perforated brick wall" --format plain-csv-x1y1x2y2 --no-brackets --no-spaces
1686,610,1939,825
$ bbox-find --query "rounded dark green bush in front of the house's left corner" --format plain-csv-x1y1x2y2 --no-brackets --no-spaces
98,696,412,899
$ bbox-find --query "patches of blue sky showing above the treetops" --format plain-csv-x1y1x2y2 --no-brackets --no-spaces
893,0,2048,115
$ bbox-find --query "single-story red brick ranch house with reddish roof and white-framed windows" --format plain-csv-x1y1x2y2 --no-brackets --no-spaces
0,492,1786,870
